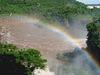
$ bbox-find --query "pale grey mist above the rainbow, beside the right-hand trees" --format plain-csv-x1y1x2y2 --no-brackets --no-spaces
66,17,91,39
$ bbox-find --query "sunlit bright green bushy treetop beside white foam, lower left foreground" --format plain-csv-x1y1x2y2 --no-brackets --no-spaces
18,49,47,72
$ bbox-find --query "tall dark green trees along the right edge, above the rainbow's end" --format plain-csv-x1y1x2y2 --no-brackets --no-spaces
87,15,100,61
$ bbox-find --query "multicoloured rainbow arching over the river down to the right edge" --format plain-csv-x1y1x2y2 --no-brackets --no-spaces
34,22,100,74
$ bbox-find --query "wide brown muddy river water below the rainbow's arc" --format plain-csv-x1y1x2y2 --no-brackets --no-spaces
0,19,86,75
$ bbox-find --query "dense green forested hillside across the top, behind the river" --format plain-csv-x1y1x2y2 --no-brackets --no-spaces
0,0,100,25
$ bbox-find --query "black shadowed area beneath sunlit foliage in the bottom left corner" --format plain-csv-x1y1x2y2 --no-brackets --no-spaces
0,52,31,75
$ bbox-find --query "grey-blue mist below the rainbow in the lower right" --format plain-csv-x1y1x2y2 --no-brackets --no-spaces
50,47,100,75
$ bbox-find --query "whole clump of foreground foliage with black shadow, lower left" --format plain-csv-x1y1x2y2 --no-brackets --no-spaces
0,42,47,75
